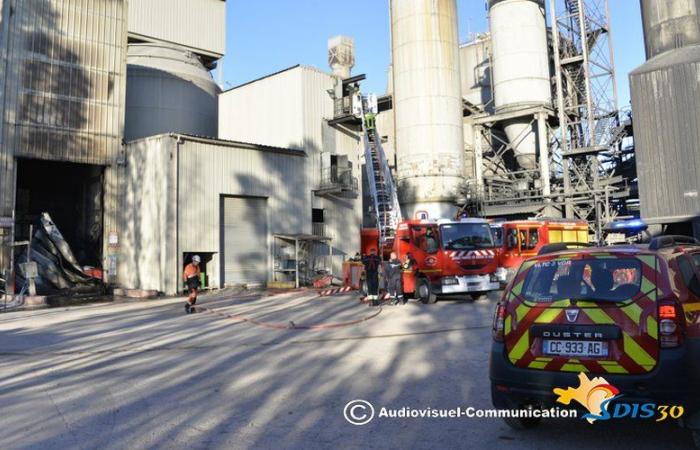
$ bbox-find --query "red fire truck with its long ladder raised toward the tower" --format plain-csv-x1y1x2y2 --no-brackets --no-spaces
350,93,500,303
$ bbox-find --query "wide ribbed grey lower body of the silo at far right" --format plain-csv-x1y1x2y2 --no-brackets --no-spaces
630,46,700,222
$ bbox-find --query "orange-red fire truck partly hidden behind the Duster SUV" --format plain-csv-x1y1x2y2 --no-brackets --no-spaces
491,219,588,284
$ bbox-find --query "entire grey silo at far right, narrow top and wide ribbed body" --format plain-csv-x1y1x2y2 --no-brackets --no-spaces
630,0,700,237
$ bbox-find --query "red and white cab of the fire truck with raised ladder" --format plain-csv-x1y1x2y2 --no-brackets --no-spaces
393,219,500,303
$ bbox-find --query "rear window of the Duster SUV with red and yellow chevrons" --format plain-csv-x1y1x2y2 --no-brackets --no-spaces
522,258,642,303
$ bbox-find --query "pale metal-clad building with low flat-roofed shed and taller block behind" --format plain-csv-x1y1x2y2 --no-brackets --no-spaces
112,66,361,294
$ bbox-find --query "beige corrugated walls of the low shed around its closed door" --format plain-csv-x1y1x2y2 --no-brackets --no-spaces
116,135,311,294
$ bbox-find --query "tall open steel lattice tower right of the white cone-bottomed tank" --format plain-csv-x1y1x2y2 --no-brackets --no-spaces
549,0,628,239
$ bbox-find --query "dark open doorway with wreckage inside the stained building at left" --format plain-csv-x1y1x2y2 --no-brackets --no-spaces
15,159,104,267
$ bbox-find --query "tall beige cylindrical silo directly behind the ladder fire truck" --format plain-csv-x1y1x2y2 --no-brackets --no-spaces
390,0,464,218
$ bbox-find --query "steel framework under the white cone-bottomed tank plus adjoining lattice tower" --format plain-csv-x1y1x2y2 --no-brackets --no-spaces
464,0,634,243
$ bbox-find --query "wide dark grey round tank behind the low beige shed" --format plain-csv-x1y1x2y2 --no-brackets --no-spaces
124,44,220,142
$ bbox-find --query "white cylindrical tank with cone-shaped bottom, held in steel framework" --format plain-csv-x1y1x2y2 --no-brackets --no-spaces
489,0,552,170
